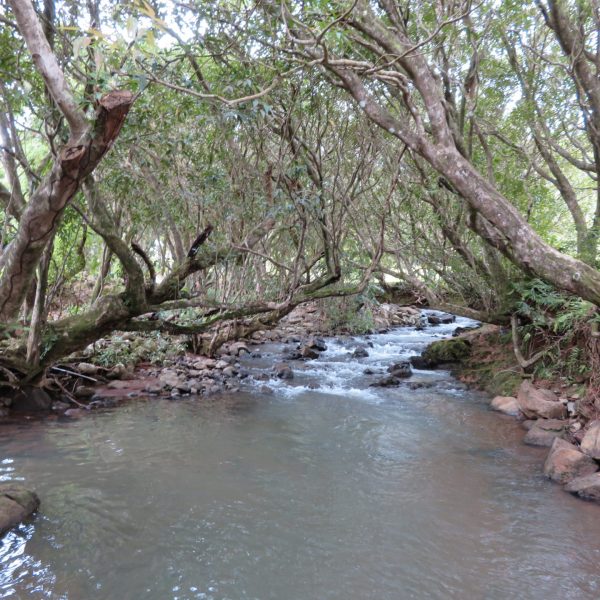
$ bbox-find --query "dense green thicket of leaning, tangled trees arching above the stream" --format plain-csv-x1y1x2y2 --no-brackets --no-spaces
0,0,600,408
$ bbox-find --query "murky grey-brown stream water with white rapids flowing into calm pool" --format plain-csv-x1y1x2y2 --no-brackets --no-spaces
0,320,600,600
